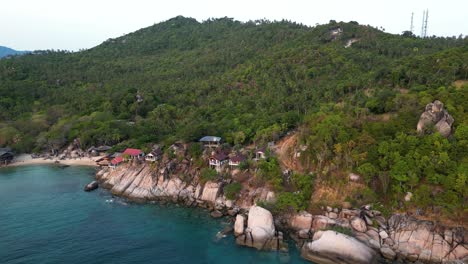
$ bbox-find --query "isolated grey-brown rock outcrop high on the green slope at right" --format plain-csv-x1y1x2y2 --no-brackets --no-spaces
416,100,454,137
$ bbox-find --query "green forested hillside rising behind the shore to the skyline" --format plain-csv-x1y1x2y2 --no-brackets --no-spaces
0,17,468,221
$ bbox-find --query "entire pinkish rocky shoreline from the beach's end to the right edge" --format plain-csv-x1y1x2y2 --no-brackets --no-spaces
96,154,468,263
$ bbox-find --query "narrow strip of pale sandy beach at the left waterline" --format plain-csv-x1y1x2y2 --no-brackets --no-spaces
8,154,101,167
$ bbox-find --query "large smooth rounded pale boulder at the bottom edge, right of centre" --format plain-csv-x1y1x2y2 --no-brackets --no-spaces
301,230,377,264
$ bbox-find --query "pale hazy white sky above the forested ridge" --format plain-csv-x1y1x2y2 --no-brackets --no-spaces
0,0,468,50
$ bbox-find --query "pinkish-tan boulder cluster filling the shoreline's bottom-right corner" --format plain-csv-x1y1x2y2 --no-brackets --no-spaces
288,206,468,263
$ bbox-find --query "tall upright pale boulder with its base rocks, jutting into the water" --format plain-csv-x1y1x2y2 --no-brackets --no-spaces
235,205,287,250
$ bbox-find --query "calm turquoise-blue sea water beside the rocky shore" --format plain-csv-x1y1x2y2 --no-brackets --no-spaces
0,166,307,264
